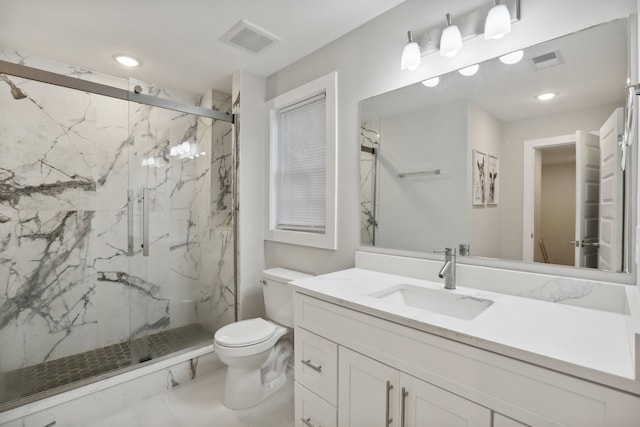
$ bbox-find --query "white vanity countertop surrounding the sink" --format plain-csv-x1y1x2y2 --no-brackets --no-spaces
293,268,640,395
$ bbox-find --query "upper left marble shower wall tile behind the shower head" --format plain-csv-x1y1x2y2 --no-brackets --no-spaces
0,76,96,210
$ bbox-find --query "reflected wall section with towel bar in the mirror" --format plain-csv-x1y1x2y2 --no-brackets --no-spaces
376,101,469,252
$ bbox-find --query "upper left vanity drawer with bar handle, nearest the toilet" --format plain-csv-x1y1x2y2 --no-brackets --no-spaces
295,327,338,406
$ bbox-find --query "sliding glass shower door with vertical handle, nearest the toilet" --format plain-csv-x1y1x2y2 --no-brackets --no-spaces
129,85,224,363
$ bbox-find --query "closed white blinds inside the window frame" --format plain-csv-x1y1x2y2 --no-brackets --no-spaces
276,93,326,233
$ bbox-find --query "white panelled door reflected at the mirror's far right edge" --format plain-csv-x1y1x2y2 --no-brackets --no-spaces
598,108,623,271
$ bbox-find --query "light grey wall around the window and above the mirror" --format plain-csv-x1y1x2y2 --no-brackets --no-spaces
254,0,637,274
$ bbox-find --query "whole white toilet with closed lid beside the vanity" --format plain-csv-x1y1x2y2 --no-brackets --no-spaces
213,268,311,409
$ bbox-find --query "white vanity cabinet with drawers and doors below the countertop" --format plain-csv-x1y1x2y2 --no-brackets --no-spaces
294,292,640,427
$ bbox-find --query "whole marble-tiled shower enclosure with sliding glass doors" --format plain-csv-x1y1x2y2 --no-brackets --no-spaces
0,55,236,411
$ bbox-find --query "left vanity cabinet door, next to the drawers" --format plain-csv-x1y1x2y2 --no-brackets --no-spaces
338,347,400,427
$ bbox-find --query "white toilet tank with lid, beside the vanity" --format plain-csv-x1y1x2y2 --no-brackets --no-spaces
262,268,312,328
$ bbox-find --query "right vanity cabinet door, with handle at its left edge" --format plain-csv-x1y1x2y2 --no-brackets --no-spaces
401,373,491,427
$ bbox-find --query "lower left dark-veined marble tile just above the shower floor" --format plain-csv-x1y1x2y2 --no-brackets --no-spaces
0,210,96,370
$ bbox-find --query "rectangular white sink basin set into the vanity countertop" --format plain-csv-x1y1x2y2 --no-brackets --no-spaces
371,284,493,320
